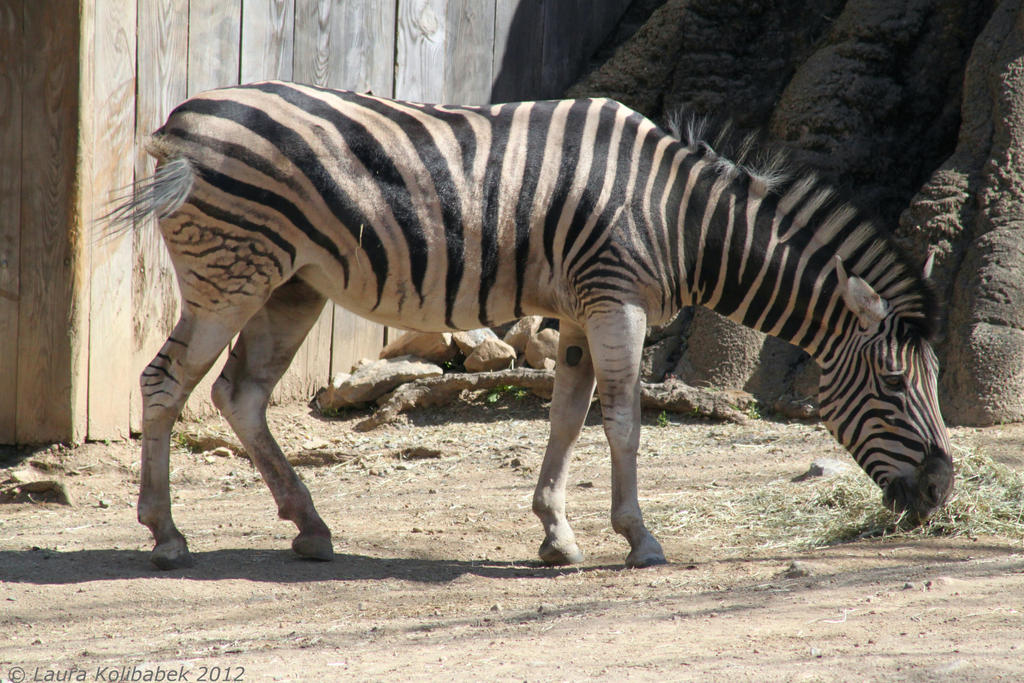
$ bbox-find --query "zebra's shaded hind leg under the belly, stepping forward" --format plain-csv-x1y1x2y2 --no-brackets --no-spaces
212,278,334,560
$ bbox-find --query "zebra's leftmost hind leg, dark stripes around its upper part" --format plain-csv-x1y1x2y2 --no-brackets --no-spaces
138,304,244,569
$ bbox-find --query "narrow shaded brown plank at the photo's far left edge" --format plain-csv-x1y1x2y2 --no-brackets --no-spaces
0,0,25,443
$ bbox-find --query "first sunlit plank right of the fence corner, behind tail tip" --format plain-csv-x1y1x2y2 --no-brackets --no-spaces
82,0,138,439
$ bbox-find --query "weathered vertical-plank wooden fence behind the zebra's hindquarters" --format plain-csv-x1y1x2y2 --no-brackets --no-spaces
0,0,629,443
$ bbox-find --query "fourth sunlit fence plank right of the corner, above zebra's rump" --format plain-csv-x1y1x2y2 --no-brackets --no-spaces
241,0,295,83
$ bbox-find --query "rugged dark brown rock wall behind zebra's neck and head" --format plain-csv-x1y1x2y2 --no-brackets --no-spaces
569,0,1024,424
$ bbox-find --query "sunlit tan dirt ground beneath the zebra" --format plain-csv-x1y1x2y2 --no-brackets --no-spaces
0,396,1024,683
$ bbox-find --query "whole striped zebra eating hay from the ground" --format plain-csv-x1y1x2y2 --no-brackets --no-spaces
110,82,953,568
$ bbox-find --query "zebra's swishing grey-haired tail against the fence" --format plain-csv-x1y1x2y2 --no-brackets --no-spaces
97,157,196,241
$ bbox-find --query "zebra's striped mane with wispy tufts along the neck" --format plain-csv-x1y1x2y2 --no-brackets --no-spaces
667,110,941,340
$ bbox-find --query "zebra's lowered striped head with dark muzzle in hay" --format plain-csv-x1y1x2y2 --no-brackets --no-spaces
818,258,953,523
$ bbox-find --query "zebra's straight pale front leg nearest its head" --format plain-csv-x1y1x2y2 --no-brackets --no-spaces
587,306,666,567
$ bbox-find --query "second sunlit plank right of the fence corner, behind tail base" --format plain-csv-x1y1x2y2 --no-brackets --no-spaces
129,0,188,433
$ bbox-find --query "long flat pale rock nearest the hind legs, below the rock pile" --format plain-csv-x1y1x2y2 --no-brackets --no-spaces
315,356,442,413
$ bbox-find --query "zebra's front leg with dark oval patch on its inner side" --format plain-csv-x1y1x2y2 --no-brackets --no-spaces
534,322,594,564
